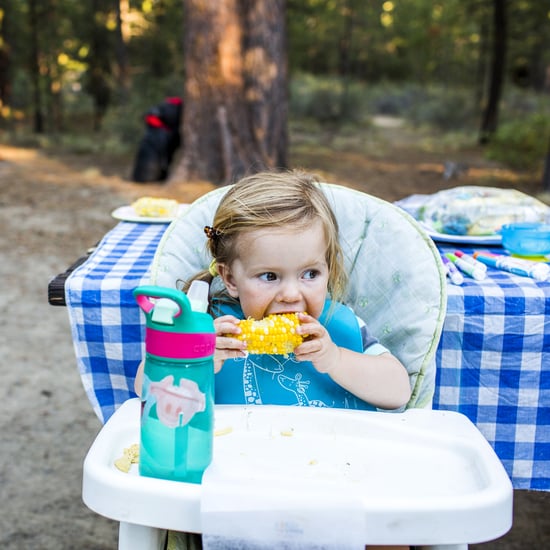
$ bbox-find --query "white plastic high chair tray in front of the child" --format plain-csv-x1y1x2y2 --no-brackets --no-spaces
83,399,513,544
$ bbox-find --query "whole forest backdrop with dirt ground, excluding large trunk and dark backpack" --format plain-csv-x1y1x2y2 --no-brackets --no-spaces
0,0,550,550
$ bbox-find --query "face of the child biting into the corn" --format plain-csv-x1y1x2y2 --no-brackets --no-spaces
218,221,329,319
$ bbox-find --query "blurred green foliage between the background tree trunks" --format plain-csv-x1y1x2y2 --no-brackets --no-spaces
0,0,550,157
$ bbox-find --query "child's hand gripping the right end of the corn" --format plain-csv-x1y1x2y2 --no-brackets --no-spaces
294,313,340,373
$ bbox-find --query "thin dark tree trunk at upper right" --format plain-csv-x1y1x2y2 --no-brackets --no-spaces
479,0,508,144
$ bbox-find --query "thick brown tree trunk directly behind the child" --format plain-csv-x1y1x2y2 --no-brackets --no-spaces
170,0,288,183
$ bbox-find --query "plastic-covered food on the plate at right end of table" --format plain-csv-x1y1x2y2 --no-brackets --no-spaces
418,186,550,236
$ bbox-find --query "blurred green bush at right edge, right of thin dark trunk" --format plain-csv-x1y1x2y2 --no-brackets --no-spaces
486,112,550,170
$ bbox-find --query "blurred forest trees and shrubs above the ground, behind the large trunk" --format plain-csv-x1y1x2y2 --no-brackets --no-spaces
0,0,550,188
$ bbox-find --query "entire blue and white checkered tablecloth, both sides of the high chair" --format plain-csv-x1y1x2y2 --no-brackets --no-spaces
65,222,550,490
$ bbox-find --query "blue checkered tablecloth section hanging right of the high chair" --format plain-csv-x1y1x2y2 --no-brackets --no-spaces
434,246,550,490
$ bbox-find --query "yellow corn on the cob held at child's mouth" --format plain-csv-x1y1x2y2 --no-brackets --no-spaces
233,313,303,355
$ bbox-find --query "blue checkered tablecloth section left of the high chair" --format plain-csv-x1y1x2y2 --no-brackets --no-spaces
65,222,168,422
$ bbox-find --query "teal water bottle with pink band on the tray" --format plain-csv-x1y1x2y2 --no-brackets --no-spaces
134,281,216,483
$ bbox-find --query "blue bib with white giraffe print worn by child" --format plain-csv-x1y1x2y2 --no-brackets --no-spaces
213,300,375,410
